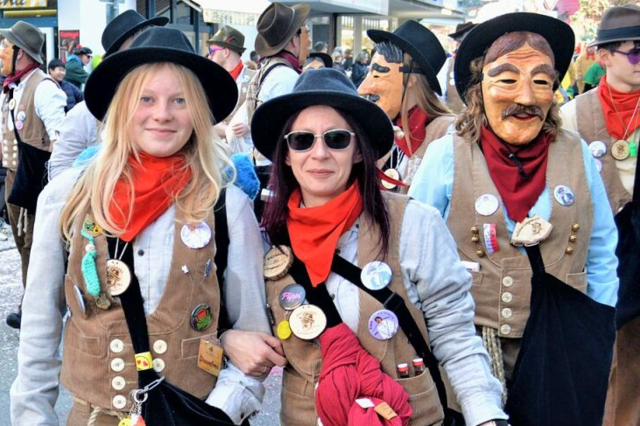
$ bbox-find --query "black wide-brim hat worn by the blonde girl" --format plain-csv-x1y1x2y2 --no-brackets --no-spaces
84,27,238,122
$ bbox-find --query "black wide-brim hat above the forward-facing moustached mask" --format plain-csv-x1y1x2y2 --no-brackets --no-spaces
453,12,575,103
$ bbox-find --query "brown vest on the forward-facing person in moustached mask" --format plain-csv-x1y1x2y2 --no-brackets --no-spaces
447,131,593,338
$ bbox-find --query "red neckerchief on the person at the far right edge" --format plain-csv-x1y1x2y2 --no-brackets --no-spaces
598,75,640,139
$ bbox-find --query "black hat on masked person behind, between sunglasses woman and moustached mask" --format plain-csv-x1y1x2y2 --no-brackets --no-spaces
367,21,447,95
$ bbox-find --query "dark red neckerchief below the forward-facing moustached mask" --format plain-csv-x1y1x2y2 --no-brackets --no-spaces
480,127,553,222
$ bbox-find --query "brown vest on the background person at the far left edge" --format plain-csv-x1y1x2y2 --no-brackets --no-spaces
2,69,57,171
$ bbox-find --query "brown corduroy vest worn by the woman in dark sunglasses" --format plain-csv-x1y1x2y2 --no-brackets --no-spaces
266,193,444,426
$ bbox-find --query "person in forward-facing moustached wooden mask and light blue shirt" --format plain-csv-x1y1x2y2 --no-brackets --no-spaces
409,13,618,421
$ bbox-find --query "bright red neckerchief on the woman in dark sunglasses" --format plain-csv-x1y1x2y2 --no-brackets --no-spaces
287,181,363,287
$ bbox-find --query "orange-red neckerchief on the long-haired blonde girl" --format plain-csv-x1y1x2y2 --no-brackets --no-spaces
109,152,191,241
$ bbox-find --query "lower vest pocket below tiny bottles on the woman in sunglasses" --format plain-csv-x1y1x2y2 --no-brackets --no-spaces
396,371,444,426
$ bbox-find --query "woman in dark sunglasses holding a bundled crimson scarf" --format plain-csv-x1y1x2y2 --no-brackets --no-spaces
252,69,506,426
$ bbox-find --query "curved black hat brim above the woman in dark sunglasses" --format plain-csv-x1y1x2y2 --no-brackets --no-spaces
251,90,394,161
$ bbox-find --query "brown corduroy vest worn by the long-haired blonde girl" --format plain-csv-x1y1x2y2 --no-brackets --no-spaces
61,210,220,411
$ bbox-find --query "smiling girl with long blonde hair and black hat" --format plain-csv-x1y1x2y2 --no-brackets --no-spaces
11,27,284,426
